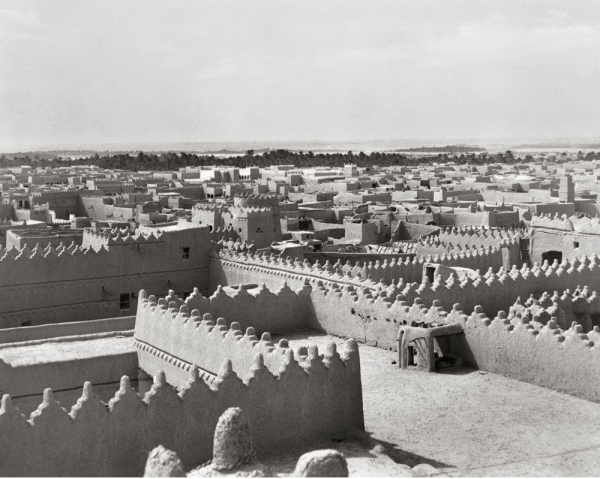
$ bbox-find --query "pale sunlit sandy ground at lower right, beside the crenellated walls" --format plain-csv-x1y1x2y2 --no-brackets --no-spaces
265,332,600,476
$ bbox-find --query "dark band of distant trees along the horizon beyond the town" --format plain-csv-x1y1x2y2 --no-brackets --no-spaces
0,150,600,171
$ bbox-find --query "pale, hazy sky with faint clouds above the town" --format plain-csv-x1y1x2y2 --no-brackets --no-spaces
0,0,600,145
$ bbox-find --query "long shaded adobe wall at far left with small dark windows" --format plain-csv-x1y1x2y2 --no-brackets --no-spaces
0,228,212,327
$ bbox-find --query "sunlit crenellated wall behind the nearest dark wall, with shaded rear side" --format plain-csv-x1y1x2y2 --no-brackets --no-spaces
135,286,322,385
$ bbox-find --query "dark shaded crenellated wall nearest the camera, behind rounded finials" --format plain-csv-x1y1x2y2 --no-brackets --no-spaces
0,343,364,477
